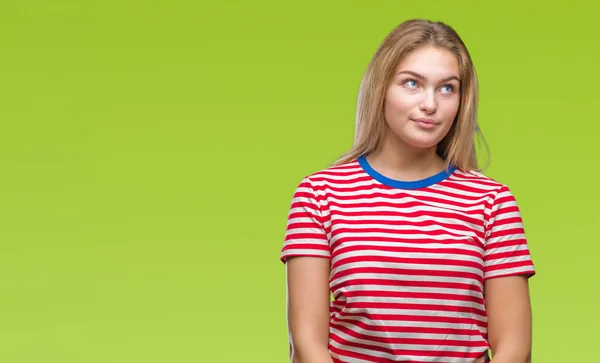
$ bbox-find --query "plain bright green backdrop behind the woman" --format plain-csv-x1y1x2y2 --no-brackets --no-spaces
0,0,600,363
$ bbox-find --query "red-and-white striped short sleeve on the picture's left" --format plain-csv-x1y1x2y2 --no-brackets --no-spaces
280,177,330,263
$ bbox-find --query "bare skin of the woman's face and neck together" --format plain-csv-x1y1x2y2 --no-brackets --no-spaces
367,47,460,181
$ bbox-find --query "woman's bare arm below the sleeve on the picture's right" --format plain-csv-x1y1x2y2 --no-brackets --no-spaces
485,276,532,363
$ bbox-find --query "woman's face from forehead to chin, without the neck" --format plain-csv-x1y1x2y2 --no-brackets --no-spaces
384,46,460,152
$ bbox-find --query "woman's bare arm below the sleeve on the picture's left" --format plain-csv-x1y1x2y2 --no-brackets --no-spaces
286,257,333,363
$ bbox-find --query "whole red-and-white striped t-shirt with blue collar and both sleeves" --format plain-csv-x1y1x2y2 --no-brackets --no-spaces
281,157,535,363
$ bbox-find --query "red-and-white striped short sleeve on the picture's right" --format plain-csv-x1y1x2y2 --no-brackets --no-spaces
484,186,535,280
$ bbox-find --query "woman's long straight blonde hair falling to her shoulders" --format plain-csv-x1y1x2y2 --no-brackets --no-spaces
333,19,489,171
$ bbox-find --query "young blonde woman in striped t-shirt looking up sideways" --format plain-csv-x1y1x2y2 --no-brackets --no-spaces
281,20,535,363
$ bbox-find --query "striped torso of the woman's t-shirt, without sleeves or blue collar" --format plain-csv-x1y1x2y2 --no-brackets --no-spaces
312,161,497,362
